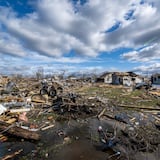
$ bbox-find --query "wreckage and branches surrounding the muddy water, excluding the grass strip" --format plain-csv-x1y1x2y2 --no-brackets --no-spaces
0,77,160,159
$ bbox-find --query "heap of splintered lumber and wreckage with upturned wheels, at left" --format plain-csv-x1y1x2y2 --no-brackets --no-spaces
0,79,97,140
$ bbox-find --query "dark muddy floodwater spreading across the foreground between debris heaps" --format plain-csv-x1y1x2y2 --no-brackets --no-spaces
0,118,160,160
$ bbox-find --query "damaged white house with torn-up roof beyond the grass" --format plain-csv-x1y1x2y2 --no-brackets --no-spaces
97,72,144,86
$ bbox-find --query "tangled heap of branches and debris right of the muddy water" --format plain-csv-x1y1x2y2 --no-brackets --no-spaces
94,103,160,160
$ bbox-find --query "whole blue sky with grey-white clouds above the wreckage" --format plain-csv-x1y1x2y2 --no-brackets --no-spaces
0,0,160,74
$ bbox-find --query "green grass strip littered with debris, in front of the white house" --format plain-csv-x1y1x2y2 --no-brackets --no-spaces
76,85,160,107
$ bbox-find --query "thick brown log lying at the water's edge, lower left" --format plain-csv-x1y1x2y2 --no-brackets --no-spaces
0,121,40,140
